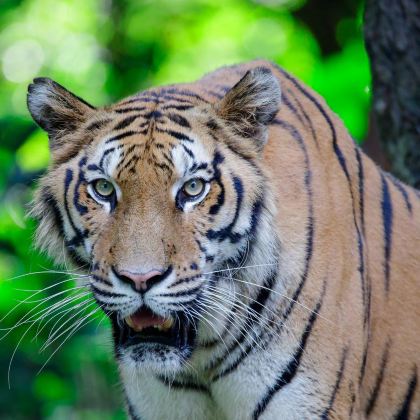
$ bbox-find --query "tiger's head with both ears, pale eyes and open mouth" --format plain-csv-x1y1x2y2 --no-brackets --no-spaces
28,68,280,372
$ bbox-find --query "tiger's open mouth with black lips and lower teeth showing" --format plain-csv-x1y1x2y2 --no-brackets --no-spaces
111,306,196,350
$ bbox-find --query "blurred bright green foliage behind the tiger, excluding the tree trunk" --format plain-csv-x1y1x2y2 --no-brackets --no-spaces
0,0,370,420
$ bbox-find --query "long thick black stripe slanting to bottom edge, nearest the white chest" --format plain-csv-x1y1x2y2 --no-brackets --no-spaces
252,281,326,420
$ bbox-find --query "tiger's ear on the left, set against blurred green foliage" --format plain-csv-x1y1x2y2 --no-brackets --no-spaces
27,77,95,152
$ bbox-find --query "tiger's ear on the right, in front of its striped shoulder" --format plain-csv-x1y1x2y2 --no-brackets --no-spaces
216,67,281,151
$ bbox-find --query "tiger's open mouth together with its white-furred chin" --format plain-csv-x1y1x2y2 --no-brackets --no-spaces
110,309,197,375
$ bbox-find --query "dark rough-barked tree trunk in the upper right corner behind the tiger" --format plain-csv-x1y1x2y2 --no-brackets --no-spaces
365,0,420,188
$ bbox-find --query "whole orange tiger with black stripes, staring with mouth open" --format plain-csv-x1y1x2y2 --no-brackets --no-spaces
27,60,420,420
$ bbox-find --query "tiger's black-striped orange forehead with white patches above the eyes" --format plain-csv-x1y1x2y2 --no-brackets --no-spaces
87,92,210,179
